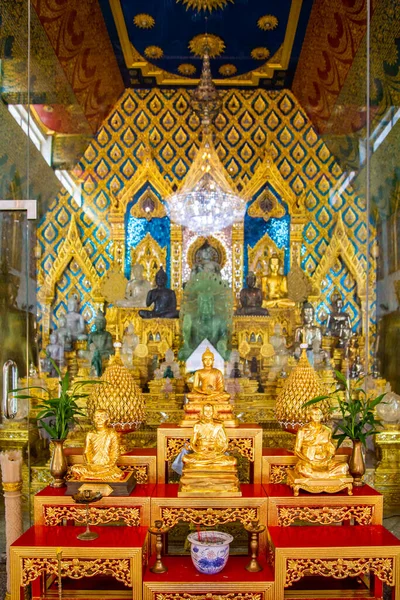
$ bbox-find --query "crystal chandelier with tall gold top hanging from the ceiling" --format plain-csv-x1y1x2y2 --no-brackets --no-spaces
168,48,246,235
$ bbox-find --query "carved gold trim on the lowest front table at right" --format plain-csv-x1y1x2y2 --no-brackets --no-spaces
285,557,394,588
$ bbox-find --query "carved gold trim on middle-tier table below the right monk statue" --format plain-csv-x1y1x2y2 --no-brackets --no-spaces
277,506,373,527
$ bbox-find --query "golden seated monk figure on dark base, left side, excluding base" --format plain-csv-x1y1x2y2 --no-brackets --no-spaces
71,409,124,481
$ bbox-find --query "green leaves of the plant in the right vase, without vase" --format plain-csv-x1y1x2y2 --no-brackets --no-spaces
303,371,385,447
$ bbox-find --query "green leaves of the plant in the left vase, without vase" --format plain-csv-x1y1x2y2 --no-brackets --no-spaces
12,357,99,440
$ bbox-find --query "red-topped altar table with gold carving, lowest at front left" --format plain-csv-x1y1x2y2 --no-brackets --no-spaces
10,525,148,600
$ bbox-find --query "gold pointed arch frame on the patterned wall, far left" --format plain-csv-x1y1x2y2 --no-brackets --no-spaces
38,215,104,347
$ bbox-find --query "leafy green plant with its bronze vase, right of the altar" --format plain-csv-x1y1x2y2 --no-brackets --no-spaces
304,371,385,487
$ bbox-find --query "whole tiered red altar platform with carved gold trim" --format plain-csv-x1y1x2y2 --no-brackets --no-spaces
11,434,400,600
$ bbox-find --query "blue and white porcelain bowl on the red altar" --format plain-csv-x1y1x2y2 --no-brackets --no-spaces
187,531,233,575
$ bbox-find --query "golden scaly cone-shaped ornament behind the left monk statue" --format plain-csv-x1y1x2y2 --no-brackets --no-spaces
87,342,145,433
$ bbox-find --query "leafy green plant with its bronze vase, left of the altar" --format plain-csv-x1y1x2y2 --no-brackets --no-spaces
12,357,98,487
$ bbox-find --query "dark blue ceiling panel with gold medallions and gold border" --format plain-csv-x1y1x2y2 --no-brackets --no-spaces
99,0,312,89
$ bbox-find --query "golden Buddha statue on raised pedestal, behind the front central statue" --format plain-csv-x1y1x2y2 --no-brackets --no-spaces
180,348,238,427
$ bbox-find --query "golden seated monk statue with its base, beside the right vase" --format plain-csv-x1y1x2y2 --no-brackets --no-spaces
288,406,353,496
